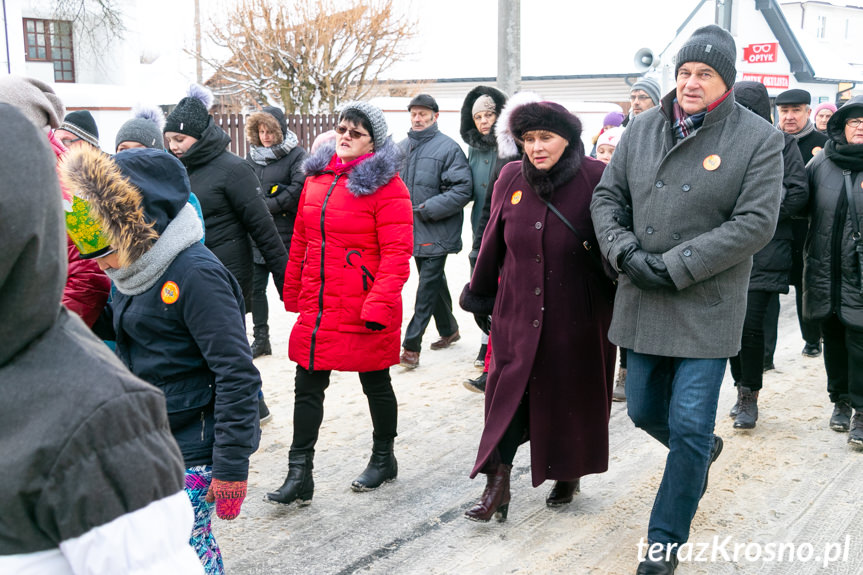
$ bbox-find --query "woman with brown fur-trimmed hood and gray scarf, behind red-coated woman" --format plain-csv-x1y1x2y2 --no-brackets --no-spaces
246,106,306,357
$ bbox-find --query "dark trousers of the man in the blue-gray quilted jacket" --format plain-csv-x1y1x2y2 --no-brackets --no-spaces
404,254,458,351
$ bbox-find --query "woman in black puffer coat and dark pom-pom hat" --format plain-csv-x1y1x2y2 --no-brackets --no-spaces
164,84,288,309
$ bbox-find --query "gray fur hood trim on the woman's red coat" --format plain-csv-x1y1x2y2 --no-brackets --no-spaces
303,137,403,197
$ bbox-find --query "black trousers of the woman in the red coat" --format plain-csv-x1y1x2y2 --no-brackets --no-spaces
291,365,398,452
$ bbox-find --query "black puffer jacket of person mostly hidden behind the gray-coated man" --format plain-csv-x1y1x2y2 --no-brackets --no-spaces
734,82,809,293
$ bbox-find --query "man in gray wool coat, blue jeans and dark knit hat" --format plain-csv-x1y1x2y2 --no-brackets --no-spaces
591,25,783,575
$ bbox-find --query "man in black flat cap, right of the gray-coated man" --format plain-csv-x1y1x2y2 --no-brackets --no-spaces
764,89,827,369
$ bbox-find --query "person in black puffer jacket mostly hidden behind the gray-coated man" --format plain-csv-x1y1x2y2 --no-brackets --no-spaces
730,82,809,429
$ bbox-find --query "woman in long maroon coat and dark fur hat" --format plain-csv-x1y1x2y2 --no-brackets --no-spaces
462,98,616,521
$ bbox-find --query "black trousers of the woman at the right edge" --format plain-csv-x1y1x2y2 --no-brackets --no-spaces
821,314,863,411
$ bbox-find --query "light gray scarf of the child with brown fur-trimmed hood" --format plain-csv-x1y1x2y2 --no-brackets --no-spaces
105,204,204,295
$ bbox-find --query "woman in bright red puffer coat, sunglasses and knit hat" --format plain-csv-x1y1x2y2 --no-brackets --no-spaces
266,102,413,505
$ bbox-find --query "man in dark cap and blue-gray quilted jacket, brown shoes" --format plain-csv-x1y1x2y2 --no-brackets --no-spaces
399,94,473,369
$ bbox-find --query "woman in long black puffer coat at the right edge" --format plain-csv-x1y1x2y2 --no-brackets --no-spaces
803,96,863,449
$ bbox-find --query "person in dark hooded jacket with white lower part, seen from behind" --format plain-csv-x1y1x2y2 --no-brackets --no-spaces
0,104,202,574
